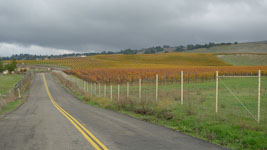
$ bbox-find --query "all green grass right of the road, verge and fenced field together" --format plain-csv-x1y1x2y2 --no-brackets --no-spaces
54,72,267,149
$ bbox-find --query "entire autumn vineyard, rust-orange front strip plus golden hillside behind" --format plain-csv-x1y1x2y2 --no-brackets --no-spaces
16,53,267,83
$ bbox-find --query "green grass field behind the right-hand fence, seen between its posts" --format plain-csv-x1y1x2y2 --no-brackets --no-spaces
84,76,267,124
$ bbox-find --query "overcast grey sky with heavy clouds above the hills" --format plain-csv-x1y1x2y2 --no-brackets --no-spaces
0,0,267,56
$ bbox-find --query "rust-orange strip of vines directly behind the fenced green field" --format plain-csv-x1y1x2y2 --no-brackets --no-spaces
64,66,267,83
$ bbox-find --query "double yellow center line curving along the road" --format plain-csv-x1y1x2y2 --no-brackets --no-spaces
43,74,108,150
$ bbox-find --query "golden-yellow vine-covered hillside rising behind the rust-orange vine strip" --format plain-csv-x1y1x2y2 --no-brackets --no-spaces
19,53,229,69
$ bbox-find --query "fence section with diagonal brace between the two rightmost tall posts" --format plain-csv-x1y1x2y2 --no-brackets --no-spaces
218,78,258,121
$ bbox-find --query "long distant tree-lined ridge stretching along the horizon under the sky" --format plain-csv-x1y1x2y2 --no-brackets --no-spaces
3,41,267,60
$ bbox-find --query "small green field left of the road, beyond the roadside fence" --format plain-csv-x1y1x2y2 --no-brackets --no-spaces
0,74,23,95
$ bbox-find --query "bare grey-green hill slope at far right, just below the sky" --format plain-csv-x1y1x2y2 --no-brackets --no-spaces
185,41,267,53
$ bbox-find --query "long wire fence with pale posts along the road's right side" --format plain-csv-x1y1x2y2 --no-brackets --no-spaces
54,71,267,124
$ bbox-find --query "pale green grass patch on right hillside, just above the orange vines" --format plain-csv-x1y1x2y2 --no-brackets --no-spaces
218,54,267,66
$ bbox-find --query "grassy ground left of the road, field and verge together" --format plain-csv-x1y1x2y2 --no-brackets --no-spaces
0,74,32,116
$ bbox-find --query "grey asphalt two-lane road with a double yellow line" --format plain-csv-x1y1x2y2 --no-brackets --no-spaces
0,74,228,150
